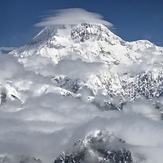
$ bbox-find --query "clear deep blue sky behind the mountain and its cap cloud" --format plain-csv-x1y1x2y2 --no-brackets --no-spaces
0,0,163,47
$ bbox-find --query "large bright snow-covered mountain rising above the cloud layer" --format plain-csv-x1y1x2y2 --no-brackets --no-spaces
9,23,163,102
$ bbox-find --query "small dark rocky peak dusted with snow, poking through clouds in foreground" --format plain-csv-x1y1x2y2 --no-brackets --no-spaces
54,131,133,163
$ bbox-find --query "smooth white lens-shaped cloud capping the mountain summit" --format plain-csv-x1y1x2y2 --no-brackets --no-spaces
35,8,113,27
